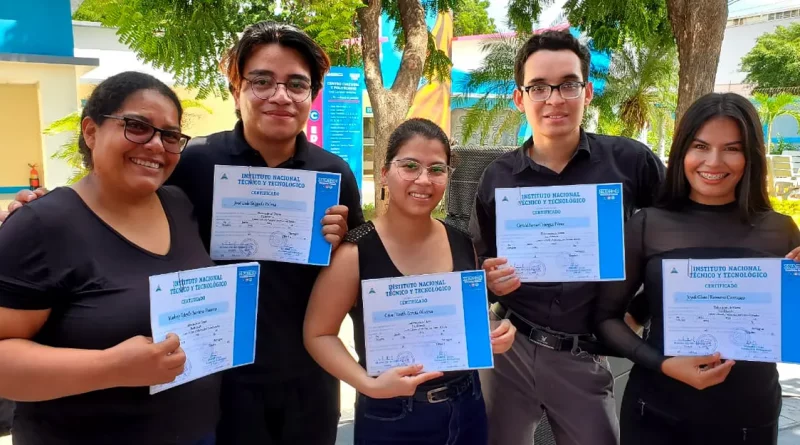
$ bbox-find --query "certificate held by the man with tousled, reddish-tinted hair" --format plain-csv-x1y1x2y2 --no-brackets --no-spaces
211,165,342,266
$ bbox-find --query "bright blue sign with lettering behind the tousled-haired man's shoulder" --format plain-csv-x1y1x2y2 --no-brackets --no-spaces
322,66,364,199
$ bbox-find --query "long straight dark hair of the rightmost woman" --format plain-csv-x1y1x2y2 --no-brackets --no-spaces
656,93,772,221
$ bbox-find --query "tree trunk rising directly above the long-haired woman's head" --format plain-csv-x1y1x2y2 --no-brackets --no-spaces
667,0,728,128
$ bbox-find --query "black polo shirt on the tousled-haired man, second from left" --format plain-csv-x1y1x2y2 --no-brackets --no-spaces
168,121,364,383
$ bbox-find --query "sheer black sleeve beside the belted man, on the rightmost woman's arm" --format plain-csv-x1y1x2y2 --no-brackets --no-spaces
595,210,665,372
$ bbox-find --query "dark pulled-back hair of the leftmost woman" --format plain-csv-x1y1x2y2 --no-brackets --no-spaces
78,71,183,169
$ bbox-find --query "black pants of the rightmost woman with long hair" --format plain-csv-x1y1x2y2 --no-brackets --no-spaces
620,384,778,445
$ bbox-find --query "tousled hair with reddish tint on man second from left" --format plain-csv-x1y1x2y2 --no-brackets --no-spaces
220,21,331,100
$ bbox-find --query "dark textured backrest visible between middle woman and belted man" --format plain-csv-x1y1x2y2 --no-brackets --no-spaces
445,145,517,230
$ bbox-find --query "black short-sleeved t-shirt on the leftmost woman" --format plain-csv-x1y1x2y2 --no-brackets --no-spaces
0,187,220,445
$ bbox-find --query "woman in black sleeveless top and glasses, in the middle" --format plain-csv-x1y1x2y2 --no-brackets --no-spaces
304,119,515,445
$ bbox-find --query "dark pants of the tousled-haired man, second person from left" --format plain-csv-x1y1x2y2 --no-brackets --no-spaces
217,371,339,445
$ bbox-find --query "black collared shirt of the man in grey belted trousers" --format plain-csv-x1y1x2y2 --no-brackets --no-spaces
470,130,664,334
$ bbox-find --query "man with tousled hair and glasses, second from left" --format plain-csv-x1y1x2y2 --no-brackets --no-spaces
0,22,364,445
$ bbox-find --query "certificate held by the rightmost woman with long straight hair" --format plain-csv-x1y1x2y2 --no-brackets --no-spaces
662,258,800,363
